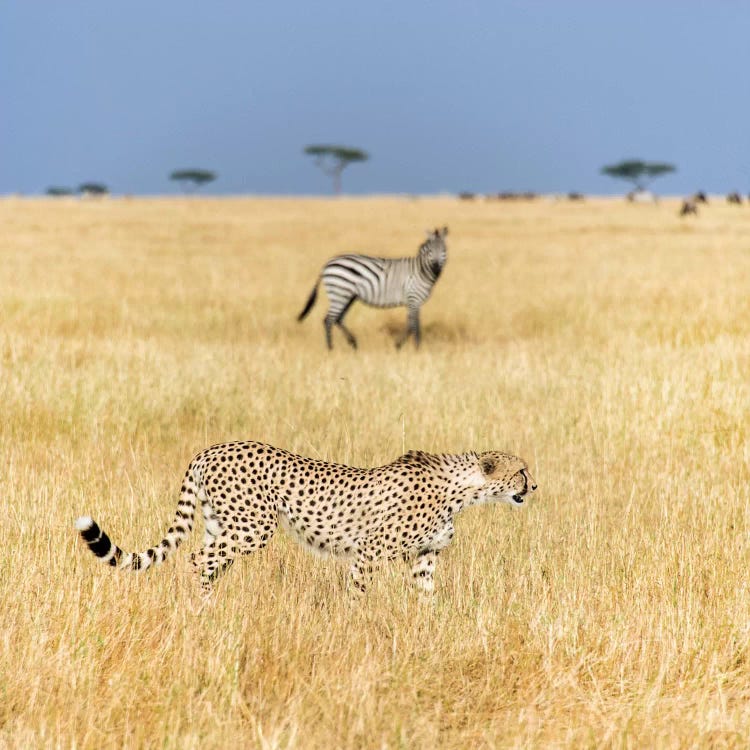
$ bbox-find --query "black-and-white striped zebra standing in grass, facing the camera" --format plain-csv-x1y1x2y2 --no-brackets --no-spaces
297,227,448,349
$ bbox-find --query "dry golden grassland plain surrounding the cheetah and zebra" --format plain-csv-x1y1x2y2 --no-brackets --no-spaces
0,198,750,749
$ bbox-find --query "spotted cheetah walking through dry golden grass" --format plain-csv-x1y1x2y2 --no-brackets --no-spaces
75,441,537,594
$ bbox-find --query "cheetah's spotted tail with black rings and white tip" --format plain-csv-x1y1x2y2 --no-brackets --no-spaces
75,477,196,570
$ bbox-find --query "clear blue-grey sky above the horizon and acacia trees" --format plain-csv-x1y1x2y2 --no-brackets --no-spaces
0,0,750,194
